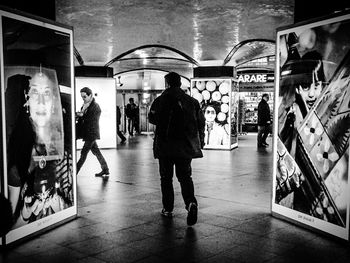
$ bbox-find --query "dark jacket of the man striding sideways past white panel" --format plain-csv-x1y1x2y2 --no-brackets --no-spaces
79,98,101,141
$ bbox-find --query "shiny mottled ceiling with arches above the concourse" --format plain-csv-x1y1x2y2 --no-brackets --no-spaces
56,0,294,78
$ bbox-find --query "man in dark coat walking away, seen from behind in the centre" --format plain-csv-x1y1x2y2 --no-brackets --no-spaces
148,72,205,226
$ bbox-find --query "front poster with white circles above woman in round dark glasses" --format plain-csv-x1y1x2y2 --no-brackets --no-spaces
191,79,238,149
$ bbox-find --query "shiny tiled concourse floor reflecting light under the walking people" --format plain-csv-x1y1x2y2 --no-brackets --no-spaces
0,134,350,263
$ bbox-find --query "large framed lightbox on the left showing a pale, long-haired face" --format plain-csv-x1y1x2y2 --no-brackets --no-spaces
0,7,77,246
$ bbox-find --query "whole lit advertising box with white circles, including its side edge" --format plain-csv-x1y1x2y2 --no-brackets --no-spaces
190,77,239,150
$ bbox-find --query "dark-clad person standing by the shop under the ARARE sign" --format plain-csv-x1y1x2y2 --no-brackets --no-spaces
258,93,271,147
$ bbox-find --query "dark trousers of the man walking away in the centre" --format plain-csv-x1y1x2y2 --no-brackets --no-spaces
159,158,197,212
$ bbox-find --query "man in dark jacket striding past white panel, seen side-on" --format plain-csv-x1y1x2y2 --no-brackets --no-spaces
77,87,109,180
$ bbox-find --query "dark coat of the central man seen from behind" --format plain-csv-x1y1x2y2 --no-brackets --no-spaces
148,88,205,159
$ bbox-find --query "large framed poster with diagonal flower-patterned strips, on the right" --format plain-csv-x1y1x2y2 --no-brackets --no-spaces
272,12,350,239
